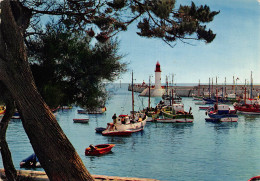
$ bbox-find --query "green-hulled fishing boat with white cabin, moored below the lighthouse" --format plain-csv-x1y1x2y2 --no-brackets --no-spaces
154,103,194,123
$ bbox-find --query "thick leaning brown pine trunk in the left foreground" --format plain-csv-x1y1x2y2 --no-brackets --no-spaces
0,0,93,181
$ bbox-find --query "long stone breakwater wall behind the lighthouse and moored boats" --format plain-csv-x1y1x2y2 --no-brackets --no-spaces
128,84,260,97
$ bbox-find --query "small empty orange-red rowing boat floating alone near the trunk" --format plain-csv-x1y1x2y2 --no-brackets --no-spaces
85,144,115,156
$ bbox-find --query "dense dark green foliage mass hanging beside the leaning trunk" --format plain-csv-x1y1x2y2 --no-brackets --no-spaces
27,24,126,108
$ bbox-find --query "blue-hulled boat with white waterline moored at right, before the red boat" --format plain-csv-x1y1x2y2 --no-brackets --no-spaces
205,104,238,122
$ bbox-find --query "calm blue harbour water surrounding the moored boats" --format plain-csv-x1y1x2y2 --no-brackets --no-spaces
0,84,260,181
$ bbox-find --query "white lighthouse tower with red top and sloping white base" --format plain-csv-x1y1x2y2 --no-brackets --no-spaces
140,62,165,97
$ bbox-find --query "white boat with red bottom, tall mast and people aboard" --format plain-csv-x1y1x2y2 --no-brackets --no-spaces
102,72,147,136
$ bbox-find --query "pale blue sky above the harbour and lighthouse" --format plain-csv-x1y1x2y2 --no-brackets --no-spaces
116,0,260,84
